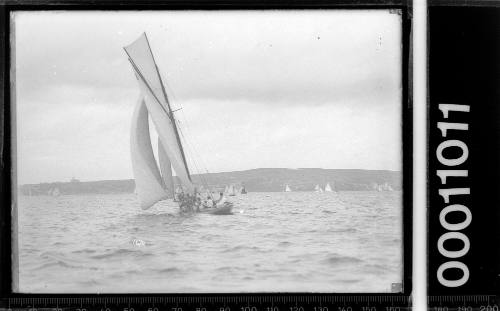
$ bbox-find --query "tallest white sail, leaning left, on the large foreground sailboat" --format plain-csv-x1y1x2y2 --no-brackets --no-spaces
125,35,194,193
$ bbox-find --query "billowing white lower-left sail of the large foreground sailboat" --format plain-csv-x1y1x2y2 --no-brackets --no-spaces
130,98,167,209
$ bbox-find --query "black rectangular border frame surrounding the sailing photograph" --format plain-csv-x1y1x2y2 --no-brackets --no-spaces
0,0,413,298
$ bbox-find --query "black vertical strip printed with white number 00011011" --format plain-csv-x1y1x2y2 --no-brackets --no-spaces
428,2,500,302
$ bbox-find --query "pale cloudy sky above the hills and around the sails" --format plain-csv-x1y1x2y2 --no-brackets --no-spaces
11,10,402,184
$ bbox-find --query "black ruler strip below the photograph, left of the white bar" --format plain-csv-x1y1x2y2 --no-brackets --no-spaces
0,294,410,311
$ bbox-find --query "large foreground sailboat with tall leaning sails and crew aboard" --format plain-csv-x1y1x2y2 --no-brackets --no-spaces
124,33,233,214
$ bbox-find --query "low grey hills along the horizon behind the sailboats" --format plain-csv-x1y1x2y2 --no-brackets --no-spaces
19,168,402,195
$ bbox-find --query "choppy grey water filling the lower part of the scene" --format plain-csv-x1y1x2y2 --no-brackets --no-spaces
18,191,402,293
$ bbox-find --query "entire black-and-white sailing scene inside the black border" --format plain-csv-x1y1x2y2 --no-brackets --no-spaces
10,9,405,293
